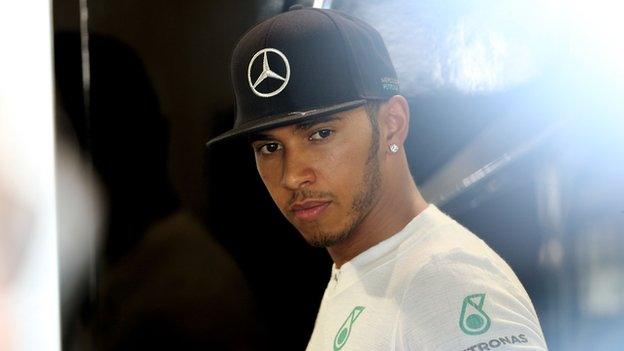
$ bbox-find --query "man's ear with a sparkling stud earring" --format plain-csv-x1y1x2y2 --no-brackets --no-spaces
382,95,409,152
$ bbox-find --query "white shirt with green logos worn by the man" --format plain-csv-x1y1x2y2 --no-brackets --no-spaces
306,205,547,351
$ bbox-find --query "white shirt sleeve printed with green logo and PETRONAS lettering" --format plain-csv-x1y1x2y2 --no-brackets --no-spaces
396,252,547,351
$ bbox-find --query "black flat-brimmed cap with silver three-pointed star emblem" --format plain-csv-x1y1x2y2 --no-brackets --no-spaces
206,6,399,146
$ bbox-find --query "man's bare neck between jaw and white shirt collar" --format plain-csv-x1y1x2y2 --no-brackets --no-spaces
327,179,427,268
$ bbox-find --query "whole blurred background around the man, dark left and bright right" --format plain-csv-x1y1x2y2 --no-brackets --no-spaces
0,0,624,350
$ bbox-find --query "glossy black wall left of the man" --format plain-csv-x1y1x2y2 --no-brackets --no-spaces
54,0,331,350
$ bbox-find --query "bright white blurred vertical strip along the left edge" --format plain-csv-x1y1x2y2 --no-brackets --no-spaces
0,0,60,351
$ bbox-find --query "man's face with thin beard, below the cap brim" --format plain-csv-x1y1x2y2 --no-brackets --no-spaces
252,108,380,247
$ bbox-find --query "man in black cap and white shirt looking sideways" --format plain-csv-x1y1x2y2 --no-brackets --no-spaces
208,7,546,351
